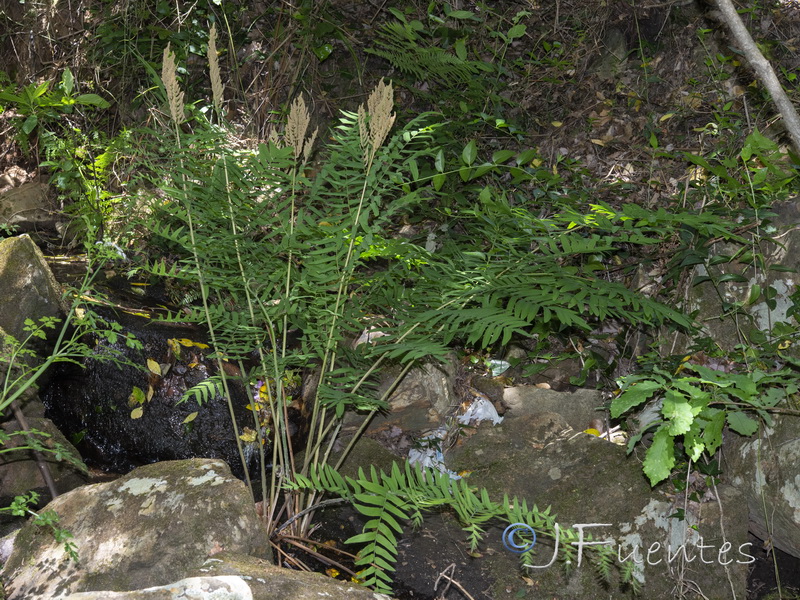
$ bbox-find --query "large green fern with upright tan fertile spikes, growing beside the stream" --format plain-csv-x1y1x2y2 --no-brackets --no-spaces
125,30,756,587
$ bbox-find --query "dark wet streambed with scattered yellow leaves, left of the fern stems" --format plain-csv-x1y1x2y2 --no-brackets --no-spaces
40,260,258,477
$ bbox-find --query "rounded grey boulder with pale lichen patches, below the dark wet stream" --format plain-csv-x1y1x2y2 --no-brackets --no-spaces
0,459,269,600
